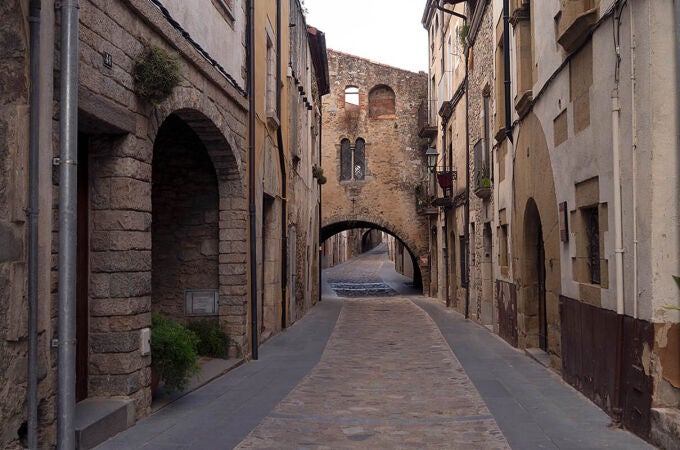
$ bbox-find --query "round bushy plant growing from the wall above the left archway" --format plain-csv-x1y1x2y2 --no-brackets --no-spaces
132,46,182,105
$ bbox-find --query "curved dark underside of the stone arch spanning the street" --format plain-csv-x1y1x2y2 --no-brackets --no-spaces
320,216,429,289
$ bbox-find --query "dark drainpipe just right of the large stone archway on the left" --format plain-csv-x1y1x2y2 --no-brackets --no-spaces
247,0,258,360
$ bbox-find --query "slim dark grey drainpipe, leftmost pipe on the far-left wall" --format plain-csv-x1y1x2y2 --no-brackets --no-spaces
26,0,41,450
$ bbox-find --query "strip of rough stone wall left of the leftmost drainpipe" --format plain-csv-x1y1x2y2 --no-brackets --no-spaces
0,0,29,448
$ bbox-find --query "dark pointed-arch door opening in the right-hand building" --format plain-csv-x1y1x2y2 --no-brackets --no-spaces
522,198,548,352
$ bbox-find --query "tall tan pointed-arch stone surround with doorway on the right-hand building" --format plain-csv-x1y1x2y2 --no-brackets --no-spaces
511,113,561,369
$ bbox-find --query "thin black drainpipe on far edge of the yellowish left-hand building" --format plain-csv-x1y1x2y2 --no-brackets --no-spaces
276,0,288,328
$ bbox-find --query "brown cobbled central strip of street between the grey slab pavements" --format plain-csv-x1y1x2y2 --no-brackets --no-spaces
237,297,509,449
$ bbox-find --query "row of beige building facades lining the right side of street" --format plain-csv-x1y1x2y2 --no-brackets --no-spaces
424,0,680,448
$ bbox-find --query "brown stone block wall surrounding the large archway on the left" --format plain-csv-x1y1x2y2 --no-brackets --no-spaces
41,0,247,436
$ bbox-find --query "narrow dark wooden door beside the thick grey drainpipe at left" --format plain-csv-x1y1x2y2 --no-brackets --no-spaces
76,134,90,401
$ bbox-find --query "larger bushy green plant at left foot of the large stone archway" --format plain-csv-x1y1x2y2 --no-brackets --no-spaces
151,314,200,391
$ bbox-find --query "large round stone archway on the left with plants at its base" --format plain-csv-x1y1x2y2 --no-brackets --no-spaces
149,106,247,353
